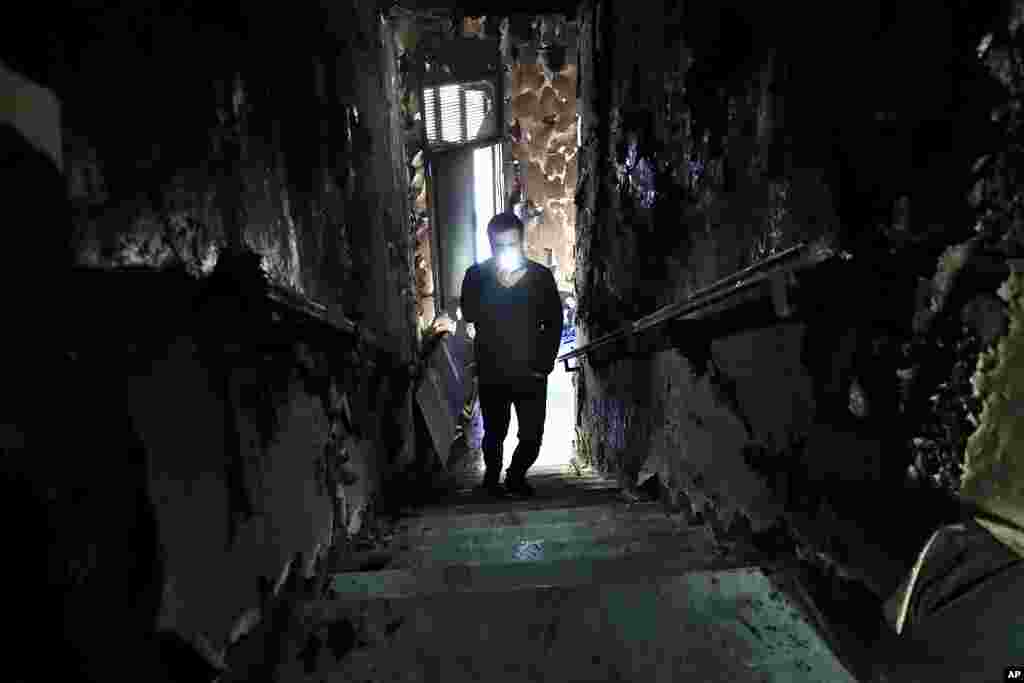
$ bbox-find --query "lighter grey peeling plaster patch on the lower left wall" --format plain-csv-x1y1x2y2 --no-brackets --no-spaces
127,337,381,666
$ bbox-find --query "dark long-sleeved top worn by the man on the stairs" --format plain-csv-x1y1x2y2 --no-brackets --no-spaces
461,258,562,384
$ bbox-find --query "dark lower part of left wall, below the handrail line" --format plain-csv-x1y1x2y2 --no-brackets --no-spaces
39,260,404,680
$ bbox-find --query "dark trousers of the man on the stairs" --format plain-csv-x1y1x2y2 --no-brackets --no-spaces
480,377,548,484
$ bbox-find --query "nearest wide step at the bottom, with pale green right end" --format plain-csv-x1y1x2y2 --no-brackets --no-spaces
296,557,855,683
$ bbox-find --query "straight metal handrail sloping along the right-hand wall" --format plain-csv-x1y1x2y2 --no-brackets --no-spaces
555,241,836,370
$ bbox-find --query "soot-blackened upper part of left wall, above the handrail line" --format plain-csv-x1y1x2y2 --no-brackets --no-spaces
56,0,414,356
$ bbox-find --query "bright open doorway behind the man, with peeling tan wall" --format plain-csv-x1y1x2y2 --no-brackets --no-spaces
423,16,580,481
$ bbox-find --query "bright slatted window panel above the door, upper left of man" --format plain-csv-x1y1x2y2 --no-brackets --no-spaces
423,81,498,147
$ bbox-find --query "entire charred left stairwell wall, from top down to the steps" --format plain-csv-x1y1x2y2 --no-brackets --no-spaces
2,1,416,680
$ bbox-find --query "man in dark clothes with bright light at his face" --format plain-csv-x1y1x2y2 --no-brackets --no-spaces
461,213,562,497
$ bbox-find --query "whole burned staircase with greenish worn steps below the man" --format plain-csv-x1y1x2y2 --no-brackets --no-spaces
288,468,854,683
